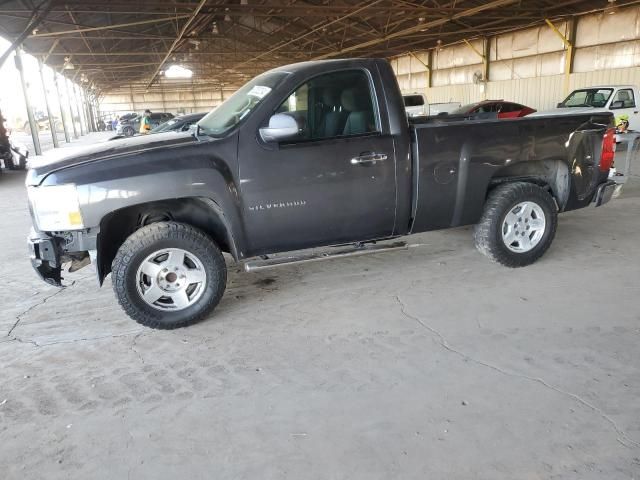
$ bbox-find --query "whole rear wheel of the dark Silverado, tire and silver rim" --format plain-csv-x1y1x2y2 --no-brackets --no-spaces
473,182,558,267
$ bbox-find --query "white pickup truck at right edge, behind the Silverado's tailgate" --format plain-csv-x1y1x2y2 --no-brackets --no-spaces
529,85,640,130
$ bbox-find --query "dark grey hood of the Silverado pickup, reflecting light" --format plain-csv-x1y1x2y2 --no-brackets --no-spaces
26,132,198,185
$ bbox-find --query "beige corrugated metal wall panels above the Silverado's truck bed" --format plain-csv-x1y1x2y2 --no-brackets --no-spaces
391,7,640,110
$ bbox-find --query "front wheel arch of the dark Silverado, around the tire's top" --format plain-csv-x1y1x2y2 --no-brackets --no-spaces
96,197,239,284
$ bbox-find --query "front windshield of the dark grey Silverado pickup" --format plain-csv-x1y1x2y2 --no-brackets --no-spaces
198,72,288,137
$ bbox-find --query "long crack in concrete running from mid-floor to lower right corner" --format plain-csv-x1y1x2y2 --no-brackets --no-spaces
394,295,640,448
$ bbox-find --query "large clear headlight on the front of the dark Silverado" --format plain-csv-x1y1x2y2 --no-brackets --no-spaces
29,185,84,232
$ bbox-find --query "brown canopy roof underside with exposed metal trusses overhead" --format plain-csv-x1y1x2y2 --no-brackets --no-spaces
0,0,624,92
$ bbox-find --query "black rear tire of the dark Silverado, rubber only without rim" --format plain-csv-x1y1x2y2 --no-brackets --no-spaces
473,182,558,268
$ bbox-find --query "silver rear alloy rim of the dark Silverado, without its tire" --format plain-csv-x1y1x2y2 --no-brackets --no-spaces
502,202,547,253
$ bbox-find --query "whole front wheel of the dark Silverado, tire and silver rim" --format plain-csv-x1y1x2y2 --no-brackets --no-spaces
111,222,227,329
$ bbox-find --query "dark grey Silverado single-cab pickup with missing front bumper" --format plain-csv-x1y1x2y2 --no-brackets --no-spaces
26,59,615,328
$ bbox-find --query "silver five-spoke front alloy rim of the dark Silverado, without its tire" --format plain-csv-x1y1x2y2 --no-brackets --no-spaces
136,248,207,311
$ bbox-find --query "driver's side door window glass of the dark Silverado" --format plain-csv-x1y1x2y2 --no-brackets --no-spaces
276,70,379,140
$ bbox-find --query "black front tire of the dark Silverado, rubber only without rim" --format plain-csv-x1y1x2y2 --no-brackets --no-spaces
111,222,227,330
